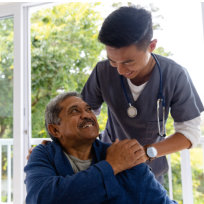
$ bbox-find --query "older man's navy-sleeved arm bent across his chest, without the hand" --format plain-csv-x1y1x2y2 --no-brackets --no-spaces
25,145,120,204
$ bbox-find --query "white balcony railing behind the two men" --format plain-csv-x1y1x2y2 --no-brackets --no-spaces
0,137,204,204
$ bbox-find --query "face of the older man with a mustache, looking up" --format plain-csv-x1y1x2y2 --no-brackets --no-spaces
53,96,99,145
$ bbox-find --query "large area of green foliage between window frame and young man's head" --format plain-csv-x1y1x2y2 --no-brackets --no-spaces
31,2,103,137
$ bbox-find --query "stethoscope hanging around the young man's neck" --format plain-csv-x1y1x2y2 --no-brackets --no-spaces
120,53,166,137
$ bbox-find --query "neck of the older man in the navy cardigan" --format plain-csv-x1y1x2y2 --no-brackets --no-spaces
63,143,93,160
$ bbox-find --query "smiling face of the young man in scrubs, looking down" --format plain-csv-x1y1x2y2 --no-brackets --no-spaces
106,45,151,79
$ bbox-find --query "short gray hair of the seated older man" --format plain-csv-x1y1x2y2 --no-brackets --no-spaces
45,92,82,141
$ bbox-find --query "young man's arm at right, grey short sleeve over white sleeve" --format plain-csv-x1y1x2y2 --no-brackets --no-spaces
133,69,203,163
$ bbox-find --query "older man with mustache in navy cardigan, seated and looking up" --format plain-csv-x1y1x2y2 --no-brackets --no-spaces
25,92,175,204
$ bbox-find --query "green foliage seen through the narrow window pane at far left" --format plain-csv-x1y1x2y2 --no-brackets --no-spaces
0,17,13,138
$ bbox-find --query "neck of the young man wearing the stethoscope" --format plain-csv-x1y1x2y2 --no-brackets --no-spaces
130,56,156,86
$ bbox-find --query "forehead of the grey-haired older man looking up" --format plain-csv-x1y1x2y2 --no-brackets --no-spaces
60,96,87,109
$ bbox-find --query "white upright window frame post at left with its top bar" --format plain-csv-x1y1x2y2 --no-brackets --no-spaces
0,2,49,204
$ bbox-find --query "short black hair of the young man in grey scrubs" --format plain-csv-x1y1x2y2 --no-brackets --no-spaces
98,6,153,49
